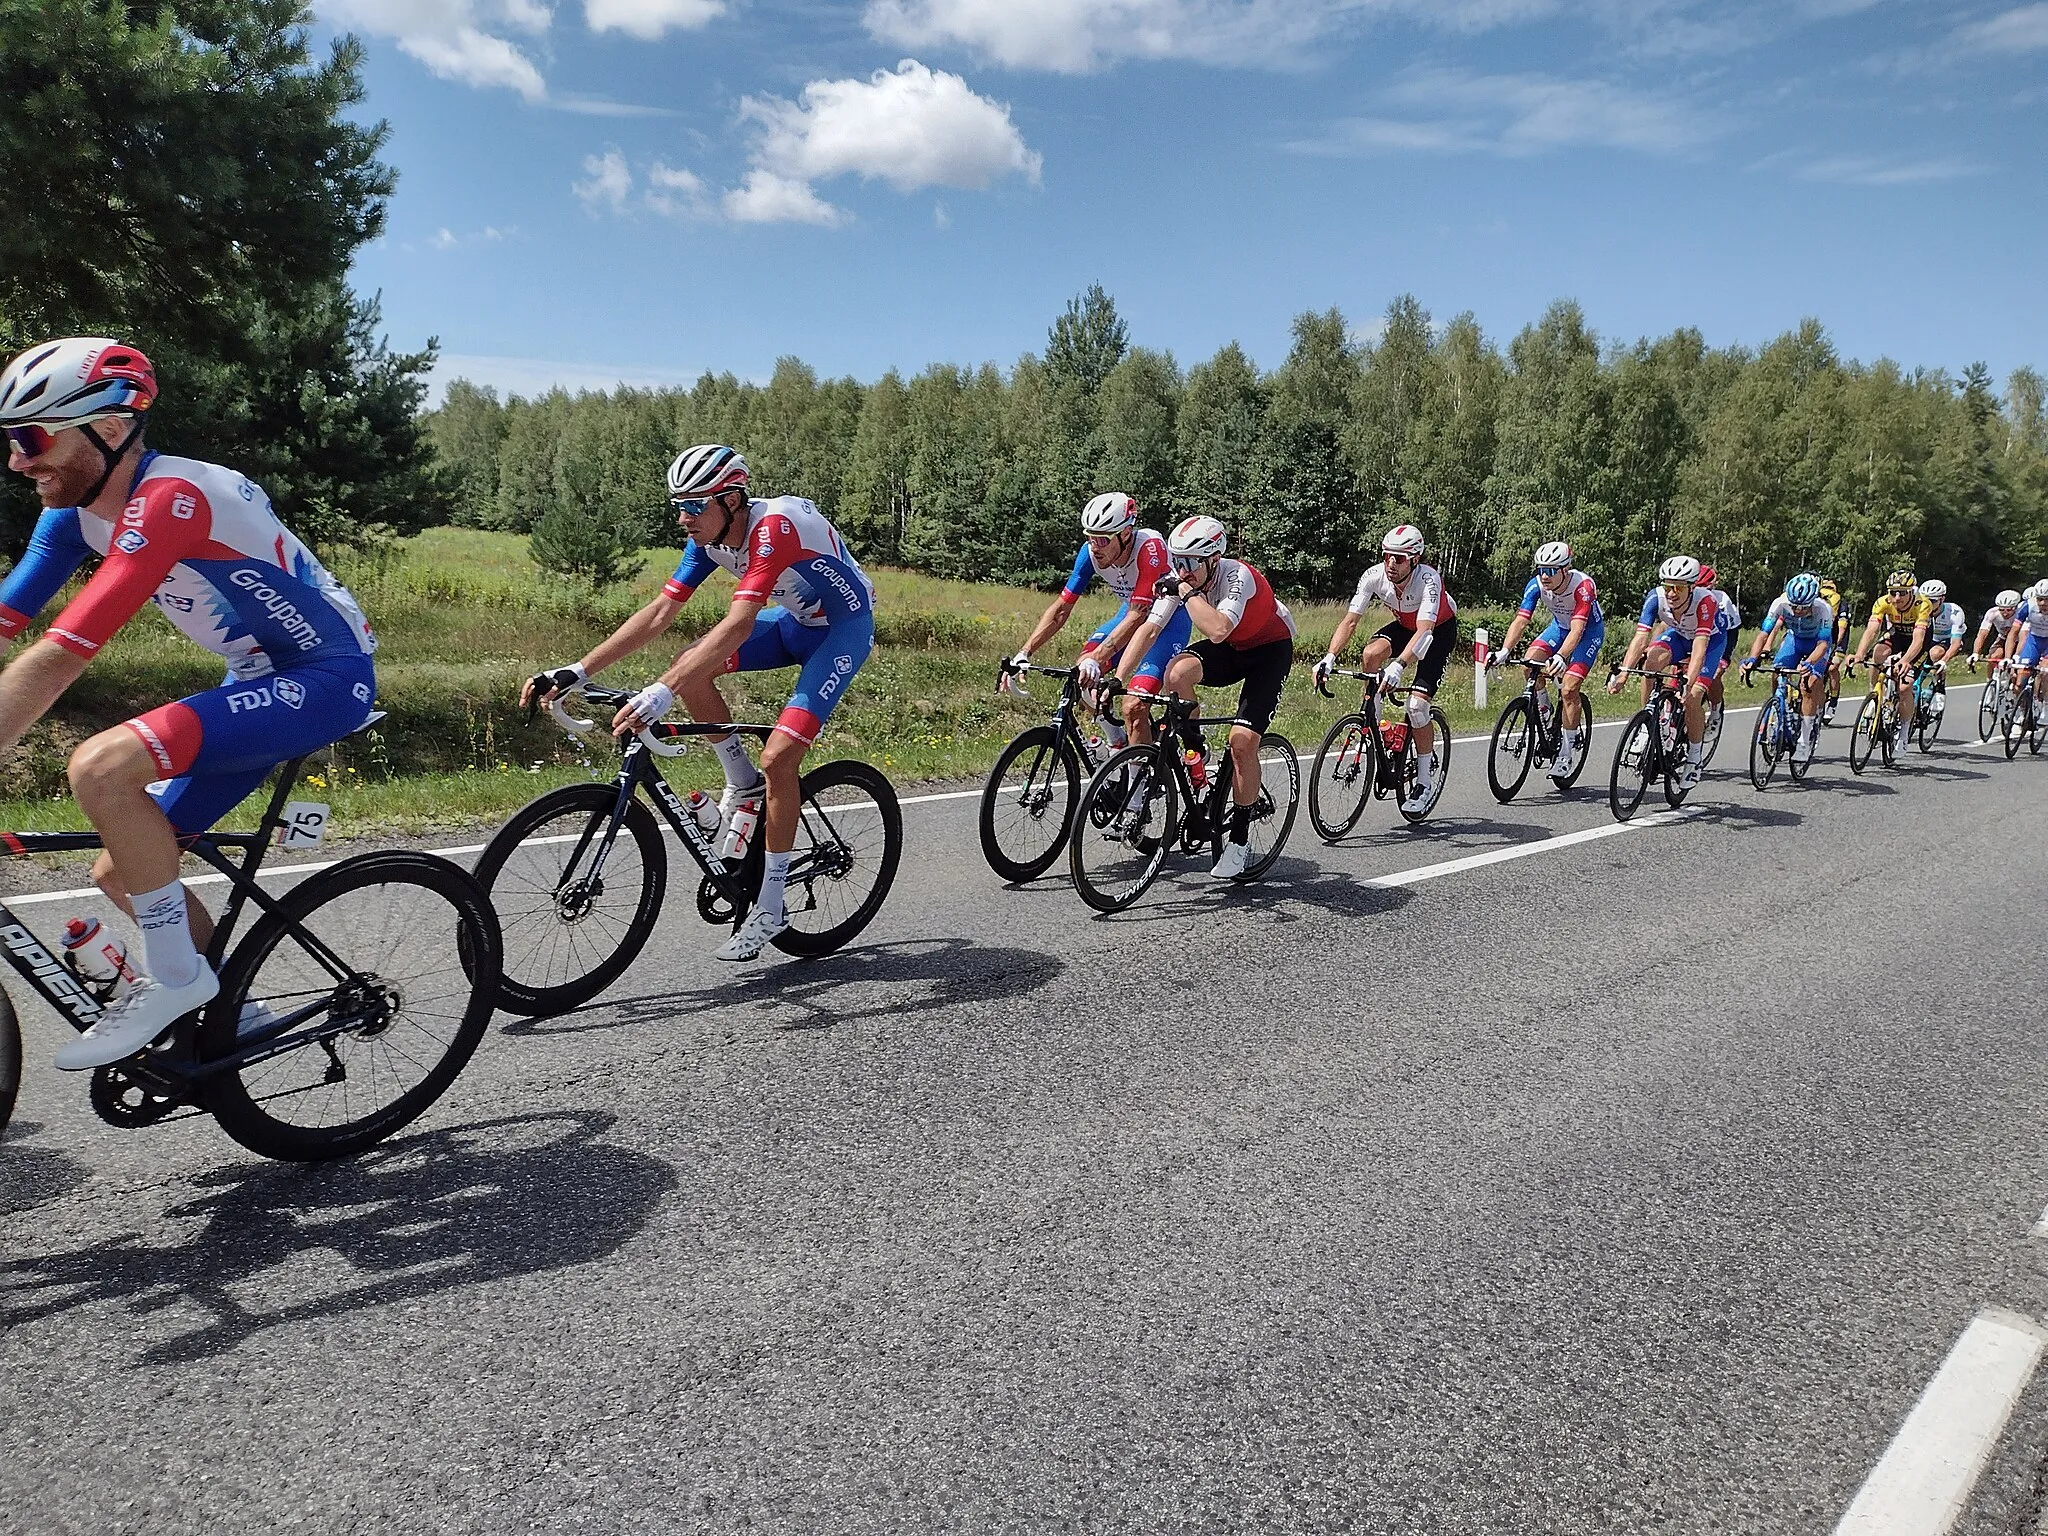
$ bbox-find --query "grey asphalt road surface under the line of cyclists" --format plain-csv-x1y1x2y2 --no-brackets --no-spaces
0,694,2048,1532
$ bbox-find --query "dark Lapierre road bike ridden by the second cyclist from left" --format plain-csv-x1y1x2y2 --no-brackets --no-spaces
477,682,903,1018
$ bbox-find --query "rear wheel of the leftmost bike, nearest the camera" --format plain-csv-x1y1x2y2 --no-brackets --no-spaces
199,850,500,1161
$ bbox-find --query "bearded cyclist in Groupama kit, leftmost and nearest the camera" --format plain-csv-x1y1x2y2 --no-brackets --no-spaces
0,336,377,1071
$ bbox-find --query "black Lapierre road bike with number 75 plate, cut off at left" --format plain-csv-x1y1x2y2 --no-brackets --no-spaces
0,729,500,1161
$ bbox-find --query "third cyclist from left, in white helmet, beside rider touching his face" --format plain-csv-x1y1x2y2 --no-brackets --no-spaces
1004,492,1190,745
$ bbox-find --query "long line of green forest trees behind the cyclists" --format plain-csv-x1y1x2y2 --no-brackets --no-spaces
426,287,2048,610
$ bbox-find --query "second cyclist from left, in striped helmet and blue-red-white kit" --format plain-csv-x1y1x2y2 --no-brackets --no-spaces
520,442,874,961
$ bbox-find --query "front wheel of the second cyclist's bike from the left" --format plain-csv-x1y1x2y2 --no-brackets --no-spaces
475,784,668,1018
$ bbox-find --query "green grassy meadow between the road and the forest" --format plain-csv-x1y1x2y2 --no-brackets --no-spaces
0,528,1540,834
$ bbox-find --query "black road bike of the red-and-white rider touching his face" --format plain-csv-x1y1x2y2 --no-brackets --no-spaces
1067,682,1300,911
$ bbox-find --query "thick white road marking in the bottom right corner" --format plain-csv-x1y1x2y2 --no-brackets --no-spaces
1835,1309,2048,1536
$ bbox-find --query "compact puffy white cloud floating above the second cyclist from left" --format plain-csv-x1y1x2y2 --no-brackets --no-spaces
739,59,1042,193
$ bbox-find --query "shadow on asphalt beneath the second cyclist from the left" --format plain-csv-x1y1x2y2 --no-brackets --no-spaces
502,938,1067,1036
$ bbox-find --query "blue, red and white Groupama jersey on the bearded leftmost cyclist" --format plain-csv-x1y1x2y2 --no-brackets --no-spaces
0,453,377,682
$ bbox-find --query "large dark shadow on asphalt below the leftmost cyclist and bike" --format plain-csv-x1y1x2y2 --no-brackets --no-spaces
0,1110,676,1364
